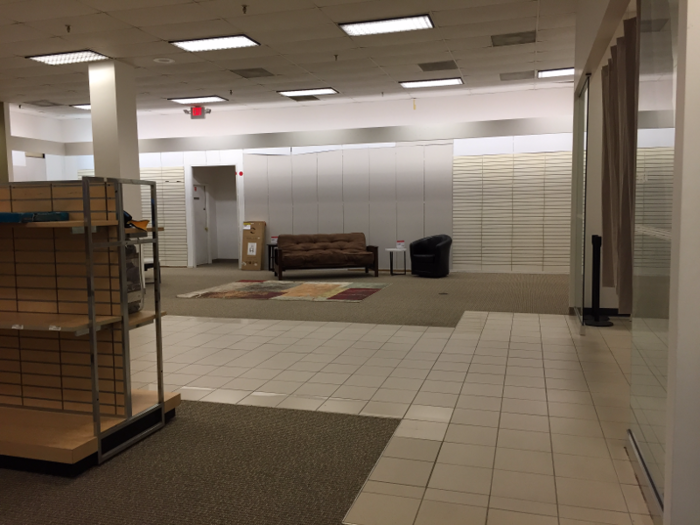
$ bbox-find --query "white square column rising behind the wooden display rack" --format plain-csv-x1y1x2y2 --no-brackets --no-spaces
90,61,141,211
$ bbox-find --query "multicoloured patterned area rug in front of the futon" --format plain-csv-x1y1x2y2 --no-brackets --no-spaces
178,281,389,303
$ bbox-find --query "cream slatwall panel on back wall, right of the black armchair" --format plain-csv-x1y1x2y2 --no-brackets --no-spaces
453,152,572,273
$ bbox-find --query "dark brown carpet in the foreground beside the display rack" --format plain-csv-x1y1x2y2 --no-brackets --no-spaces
0,402,399,525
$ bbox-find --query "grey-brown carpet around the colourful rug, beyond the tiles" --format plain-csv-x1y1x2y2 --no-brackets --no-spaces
147,263,569,327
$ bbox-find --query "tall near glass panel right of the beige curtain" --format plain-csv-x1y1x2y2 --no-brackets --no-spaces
629,0,677,522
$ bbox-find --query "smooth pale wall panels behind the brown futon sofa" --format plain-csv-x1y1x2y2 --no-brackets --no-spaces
244,141,453,268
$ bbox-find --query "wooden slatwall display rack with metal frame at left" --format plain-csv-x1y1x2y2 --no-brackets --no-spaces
0,177,180,466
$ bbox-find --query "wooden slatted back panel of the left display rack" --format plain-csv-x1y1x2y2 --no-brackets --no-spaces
0,182,125,415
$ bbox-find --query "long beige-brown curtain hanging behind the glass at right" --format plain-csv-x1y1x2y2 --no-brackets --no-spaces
602,18,639,314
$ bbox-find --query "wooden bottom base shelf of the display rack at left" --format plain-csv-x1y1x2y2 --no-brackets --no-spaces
0,390,181,464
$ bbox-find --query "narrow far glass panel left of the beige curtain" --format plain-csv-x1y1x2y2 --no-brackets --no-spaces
572,77,590,329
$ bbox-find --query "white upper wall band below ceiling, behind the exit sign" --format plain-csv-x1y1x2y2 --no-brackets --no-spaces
5,88,573,143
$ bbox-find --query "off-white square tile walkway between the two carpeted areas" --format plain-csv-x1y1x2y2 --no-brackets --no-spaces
131,312,651,525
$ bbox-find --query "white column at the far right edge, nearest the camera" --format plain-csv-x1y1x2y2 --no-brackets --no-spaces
664,0,700,525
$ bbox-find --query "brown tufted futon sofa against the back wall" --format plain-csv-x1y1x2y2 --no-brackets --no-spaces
275,233,379,281
